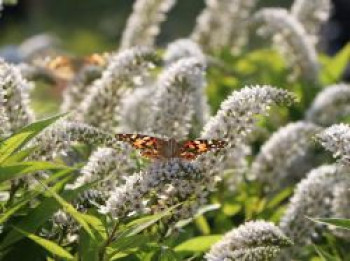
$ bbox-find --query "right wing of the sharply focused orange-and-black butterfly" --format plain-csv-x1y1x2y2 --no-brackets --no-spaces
179,140,226,160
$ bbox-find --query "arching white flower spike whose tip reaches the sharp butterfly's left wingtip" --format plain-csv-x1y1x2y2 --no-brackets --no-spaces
27,120,120,160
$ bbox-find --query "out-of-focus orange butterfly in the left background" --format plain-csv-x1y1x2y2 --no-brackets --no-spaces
34,53,107,82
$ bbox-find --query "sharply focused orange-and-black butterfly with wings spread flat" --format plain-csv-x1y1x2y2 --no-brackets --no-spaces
116,134,226,160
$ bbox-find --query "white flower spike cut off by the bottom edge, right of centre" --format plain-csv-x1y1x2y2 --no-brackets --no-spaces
206,221,292,261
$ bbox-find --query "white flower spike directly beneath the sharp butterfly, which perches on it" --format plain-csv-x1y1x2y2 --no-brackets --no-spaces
101,159,207,220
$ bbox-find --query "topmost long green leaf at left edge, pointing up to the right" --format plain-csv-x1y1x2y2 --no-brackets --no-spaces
0,114,65,163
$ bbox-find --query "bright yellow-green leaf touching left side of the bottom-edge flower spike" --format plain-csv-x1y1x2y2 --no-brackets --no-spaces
174,235,222,253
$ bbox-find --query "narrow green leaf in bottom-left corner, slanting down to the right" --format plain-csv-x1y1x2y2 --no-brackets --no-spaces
14,227,74,260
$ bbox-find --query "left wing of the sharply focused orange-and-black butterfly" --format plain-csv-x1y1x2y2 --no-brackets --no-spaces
116,134,162,159
